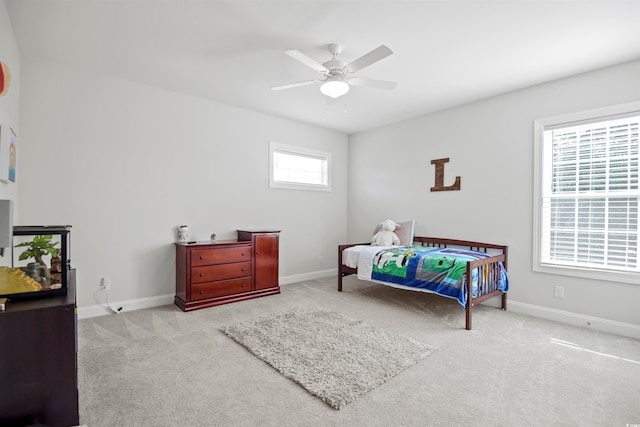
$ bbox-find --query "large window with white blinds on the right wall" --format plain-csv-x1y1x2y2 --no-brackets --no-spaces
534,103,640,283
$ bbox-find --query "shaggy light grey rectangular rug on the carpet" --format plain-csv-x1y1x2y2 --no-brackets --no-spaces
220,307,432,409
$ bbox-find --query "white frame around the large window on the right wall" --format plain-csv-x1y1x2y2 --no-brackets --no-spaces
533,102,640,284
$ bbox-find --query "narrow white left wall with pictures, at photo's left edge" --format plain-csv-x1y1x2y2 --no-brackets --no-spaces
0,0,21,207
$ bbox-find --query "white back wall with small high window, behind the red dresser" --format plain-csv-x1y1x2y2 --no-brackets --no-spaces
19,58,347,308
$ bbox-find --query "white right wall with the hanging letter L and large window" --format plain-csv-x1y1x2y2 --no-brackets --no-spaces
348,61,640,331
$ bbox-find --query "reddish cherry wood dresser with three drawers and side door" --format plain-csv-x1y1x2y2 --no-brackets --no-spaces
174,230,280,311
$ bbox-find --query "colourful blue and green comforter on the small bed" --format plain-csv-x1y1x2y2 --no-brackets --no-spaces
358,246,509,307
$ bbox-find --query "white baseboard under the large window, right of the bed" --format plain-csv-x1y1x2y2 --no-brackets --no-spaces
507,300,640,339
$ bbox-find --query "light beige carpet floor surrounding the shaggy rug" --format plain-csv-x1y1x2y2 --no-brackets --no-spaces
78,276,640,427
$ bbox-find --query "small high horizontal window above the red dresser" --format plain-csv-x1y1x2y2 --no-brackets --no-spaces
269,142,331,191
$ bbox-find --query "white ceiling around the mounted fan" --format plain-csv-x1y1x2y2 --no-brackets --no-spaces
5,0,640,133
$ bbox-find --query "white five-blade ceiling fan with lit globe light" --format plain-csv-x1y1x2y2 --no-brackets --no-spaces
271,43,396,98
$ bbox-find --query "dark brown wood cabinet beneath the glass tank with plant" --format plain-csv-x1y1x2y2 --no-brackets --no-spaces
0,269,79,427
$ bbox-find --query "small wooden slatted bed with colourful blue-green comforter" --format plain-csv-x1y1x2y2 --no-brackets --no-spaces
338,236,509,330
